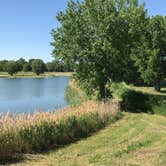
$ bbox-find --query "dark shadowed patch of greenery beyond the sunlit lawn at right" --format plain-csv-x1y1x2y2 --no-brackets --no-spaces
121,89,166,115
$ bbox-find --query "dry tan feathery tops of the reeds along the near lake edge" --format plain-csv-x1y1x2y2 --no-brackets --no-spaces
0,100,119,131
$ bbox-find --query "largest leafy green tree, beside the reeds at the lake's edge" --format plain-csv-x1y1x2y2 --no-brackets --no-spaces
52,0,146,99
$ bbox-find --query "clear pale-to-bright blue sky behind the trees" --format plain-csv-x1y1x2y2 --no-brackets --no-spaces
0,0,166,61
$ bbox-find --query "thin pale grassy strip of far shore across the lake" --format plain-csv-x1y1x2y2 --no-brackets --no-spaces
0,72,73,78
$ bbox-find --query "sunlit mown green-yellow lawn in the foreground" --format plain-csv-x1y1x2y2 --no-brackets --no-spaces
14,113,166,166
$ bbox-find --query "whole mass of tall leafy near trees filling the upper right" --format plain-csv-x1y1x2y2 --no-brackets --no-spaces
51,0,166,99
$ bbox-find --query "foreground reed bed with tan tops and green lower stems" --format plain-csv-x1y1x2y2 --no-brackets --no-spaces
0,100,120,162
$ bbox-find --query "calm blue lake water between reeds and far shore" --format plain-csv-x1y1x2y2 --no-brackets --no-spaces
0,76,70,113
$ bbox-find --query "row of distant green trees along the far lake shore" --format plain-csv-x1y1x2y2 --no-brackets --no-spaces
0,58,73,75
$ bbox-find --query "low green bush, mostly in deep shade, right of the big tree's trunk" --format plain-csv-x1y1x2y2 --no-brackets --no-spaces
110,83,166,116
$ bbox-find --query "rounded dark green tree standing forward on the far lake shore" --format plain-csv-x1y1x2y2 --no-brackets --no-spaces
32,59,46,75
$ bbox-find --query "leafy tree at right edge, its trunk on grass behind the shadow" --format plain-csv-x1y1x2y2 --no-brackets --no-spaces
133,16,166,91
